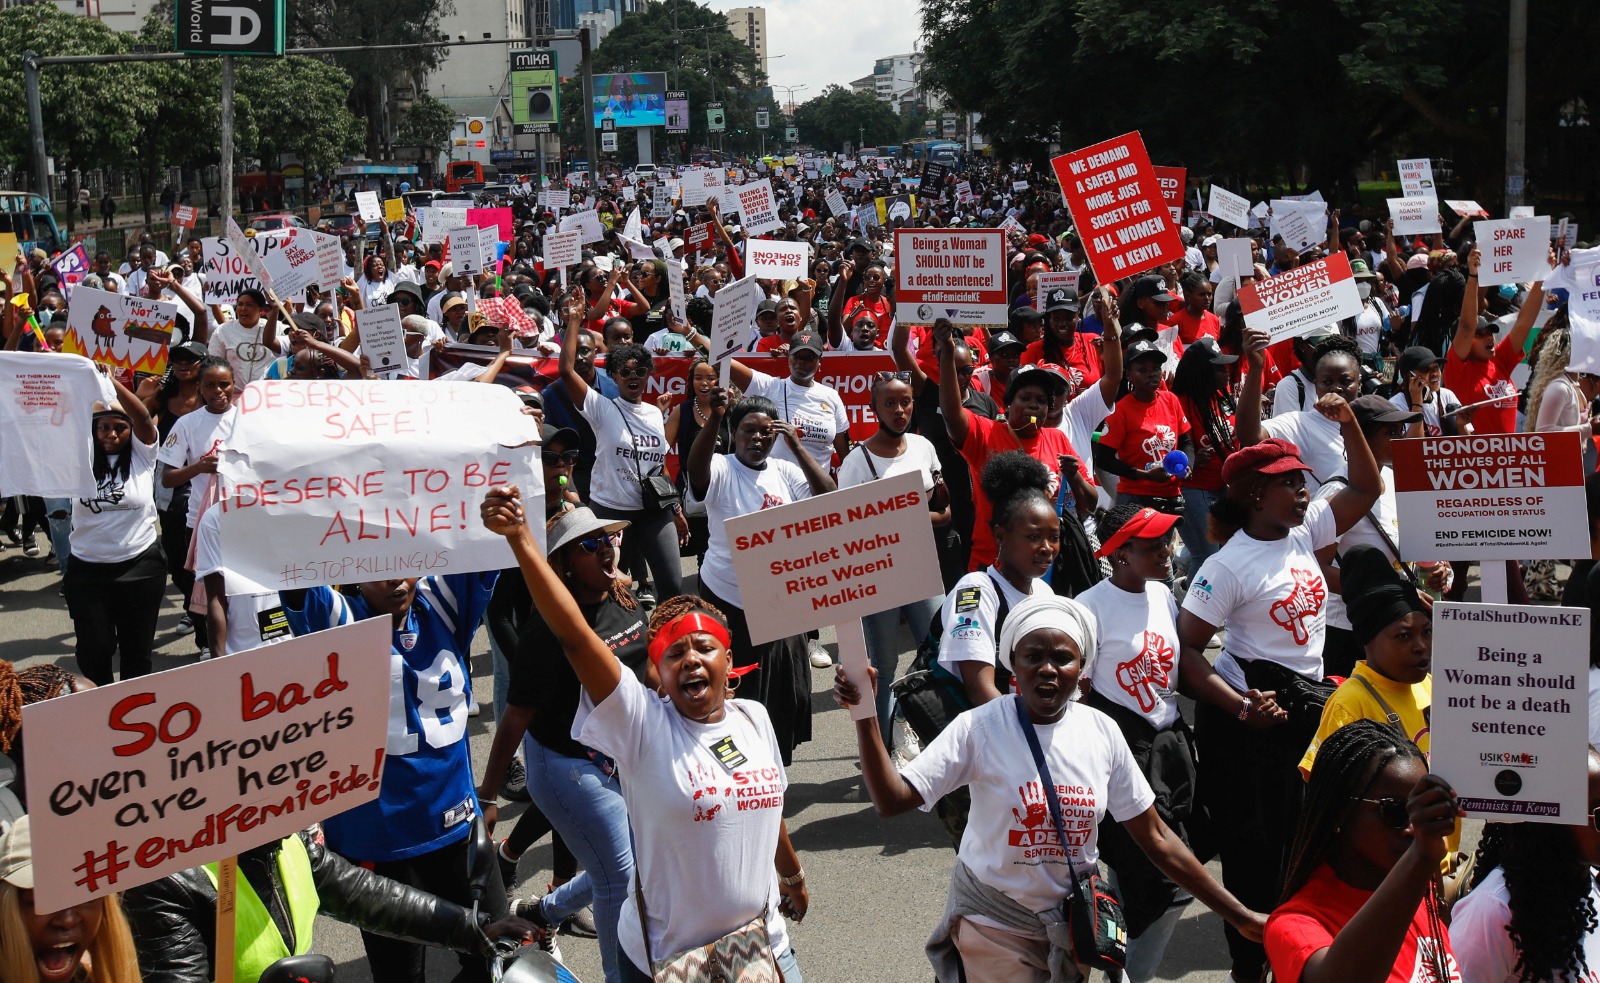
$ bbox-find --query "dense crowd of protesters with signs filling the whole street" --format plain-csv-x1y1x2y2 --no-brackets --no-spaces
0,3,1600,983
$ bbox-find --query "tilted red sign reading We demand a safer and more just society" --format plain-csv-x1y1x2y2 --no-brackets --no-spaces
1050,131,1184,283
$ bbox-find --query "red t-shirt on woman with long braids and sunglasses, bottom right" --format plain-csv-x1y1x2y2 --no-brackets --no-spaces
1266,865,1461,983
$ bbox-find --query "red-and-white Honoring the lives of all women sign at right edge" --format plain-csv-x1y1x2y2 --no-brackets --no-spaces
1394,432,1589,560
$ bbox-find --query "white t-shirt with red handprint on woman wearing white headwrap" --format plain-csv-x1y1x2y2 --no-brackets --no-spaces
901,698,1155,933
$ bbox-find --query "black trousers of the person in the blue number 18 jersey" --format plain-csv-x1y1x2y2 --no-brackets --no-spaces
350,839,507,983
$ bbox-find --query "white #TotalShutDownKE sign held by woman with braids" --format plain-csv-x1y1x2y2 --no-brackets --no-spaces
1429,600,1592,826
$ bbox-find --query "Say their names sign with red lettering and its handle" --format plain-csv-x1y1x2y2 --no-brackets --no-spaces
726,474,944,720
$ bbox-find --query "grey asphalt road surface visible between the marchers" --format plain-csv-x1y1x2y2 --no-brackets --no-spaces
0,548,1477,983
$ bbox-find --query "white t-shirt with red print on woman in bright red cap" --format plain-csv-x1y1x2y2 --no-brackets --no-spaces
1078,580,1178,730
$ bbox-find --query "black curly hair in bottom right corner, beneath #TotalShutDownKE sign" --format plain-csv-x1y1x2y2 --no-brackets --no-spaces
1465,748,1600,983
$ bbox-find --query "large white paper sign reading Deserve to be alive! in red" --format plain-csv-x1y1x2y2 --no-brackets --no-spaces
219,381,544,591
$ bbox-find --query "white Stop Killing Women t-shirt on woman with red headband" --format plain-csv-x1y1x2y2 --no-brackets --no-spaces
573,672,789,965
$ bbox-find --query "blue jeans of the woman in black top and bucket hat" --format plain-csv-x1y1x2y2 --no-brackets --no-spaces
522,736,634,983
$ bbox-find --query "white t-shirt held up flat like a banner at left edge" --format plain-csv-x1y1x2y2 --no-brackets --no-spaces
0,352,101,500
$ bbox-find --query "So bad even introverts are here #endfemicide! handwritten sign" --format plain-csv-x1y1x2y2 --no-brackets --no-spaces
22,621,390,911
